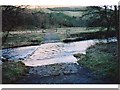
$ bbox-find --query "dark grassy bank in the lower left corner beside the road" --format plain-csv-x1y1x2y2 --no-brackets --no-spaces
2,61,29,84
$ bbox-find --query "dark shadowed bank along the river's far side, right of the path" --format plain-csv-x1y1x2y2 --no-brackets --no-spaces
63,31,116,42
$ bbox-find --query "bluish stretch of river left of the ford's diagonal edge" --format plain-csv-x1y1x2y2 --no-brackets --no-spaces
2,46,39,60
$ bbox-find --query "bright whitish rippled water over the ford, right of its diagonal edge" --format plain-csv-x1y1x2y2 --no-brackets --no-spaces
23,40,95,66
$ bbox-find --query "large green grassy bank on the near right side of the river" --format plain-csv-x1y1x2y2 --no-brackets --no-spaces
74,43,118,80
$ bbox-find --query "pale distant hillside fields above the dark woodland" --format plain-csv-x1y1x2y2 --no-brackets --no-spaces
27,7,86,17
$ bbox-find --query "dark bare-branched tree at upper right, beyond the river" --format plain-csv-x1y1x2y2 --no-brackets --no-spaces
81,5,118,40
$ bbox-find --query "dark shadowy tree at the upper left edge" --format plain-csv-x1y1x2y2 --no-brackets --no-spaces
1,6,23,43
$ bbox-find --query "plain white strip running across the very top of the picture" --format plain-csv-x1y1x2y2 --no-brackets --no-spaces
0,0,119,7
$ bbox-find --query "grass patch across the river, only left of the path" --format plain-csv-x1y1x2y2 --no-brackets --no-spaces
3,31,43,48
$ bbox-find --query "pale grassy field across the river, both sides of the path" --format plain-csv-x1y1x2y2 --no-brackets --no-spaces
2,27,99,48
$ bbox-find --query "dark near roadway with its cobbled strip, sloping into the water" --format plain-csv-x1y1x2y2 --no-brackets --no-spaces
15,64,112,84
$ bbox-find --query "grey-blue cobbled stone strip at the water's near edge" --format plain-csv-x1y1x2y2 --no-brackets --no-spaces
29,63,78,77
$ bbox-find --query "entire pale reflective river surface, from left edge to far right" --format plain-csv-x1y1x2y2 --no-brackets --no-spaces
3,38,116,66
